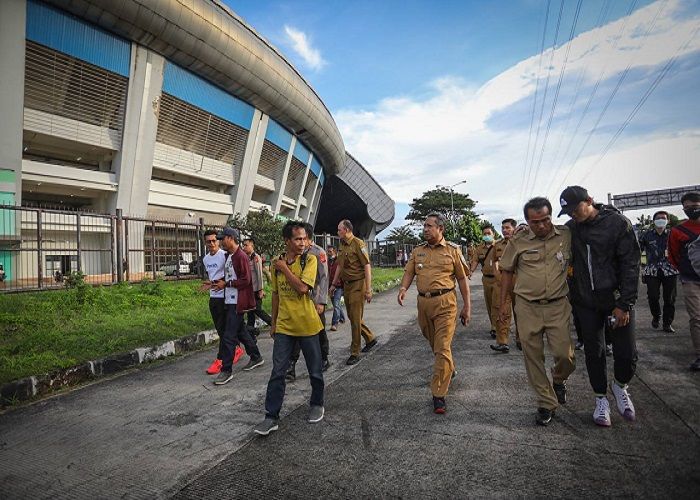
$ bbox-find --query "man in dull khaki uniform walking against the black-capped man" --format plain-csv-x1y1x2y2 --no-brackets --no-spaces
500,198,576,425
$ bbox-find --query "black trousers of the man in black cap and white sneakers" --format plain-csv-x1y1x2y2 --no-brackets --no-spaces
574,306,637,394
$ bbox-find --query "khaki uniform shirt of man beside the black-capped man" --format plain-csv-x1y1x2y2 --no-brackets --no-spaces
500,226,571,301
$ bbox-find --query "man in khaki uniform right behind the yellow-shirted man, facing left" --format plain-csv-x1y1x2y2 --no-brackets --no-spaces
329,219,377,365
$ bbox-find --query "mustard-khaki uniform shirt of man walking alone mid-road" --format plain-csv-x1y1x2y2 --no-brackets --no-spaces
405,238,466,293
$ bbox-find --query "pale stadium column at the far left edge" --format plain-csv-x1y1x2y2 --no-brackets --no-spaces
0,0,27,208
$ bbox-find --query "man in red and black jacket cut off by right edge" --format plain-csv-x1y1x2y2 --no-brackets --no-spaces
668,192,700,371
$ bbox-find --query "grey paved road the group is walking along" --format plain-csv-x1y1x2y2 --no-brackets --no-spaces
0,272,700,498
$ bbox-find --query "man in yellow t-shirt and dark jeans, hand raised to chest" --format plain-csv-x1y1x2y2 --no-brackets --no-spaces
255,221,324,436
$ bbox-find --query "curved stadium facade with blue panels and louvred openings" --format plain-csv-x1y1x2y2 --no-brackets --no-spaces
0,0,394,250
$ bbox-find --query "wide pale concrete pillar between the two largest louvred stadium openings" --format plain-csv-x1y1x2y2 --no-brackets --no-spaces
109,44,165,216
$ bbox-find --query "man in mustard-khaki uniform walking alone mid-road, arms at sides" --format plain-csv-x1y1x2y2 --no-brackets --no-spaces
398,213,471,414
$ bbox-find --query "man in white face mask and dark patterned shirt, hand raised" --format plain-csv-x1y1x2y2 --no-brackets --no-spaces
639,210,678,333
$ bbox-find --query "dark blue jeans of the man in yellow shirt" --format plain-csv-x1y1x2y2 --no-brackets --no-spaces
265,333,324,419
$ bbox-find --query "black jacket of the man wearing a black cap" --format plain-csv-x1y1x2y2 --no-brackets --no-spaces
566,204,640,311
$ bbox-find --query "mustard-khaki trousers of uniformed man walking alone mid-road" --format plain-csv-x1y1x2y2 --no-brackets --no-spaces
418,291,457,398
